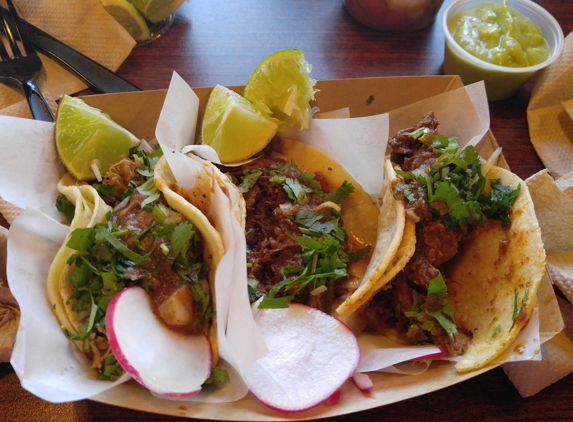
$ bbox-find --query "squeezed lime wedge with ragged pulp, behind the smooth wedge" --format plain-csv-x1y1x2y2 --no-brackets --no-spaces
244,50,316,130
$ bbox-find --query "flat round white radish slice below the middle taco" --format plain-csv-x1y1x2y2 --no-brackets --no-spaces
245,303,360,413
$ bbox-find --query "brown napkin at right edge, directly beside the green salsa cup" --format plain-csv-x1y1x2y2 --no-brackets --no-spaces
527,33,573,178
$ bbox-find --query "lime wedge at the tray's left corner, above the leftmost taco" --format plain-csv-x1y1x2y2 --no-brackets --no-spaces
54,95,141,180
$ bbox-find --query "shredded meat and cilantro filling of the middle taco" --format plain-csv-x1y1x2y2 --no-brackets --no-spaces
219,146,370,313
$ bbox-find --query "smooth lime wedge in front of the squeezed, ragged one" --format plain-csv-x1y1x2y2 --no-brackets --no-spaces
201,85,277,164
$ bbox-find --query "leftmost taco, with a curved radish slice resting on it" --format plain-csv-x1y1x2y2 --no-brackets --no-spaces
48,150,224,380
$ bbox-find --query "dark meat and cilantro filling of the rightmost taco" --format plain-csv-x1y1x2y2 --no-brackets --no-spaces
364,113,520,355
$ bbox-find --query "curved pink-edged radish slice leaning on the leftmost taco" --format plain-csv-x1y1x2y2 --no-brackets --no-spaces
105,286,212,397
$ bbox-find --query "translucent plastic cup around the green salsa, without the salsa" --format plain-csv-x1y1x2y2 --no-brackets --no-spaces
442,0,563,101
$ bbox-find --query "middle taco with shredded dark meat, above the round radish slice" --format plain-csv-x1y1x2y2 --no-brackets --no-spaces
219,139,378,324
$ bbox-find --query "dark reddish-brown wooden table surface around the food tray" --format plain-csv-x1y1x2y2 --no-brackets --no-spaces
0,0,573,421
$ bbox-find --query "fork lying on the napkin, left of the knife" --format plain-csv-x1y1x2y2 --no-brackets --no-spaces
0,0,54,122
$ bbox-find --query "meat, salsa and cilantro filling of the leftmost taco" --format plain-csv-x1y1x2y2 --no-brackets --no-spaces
49,150,214,380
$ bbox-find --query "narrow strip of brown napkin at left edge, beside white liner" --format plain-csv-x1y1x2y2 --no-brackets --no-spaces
0,226,20,362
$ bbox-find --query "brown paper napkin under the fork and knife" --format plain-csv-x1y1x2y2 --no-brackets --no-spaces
0,0,135,117
